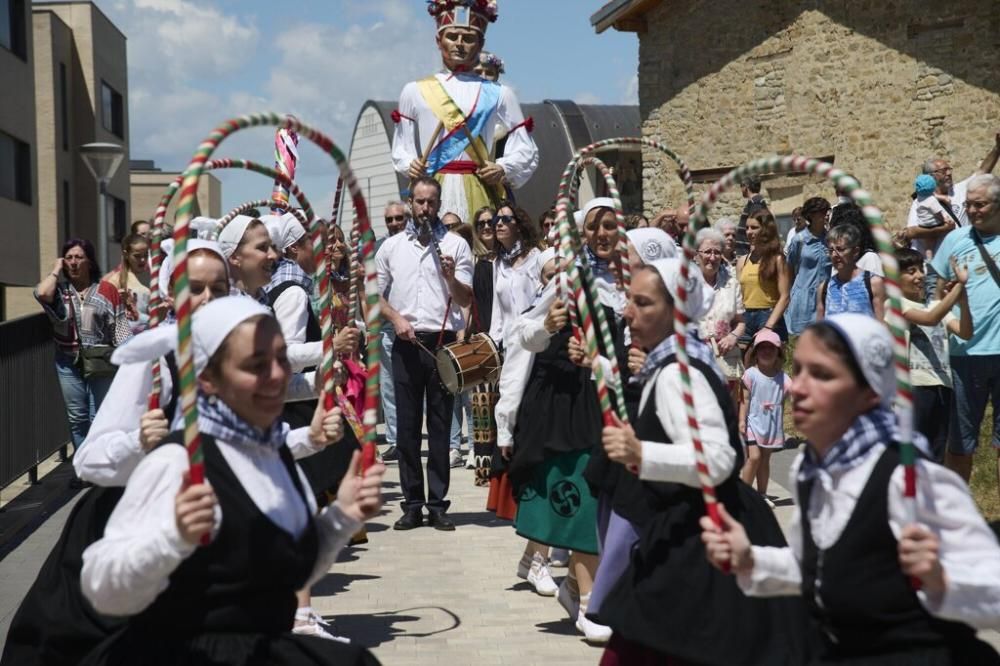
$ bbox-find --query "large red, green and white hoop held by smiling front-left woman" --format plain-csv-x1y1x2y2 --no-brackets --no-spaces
174,113,381,483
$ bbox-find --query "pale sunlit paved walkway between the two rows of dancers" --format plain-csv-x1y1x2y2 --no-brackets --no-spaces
0,452,1000,666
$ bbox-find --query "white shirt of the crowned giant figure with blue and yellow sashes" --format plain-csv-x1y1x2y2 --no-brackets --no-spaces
392,71,538,222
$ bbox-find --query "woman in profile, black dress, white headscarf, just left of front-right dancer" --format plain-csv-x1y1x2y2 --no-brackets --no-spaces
599,259,801,665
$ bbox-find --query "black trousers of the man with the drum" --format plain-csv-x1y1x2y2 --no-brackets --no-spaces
392,332,455,512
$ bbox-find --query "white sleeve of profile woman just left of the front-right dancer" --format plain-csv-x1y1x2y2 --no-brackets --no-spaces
639,364,736,488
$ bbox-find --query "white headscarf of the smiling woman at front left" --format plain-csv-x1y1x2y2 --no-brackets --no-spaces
111,296,274,375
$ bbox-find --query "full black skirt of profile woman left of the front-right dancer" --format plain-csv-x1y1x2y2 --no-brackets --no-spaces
597,479,808,666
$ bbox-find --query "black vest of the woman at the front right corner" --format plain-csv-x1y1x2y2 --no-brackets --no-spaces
798,445,975,657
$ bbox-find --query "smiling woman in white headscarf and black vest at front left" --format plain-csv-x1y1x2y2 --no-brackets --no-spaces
81,297,384,665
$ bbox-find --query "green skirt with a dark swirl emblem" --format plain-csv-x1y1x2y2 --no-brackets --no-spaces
514,451,597,555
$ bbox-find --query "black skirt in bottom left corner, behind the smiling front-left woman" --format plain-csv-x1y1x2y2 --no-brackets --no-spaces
0,488,125,666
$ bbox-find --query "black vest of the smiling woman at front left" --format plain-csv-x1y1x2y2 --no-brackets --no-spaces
129,433,318,637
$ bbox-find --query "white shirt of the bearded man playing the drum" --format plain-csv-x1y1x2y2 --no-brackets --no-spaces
375,227,473,333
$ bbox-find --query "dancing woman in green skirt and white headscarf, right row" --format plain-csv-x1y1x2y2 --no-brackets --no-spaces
508,199,625,642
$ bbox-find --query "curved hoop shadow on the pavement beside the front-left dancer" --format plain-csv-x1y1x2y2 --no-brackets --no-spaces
324,606,462,648
